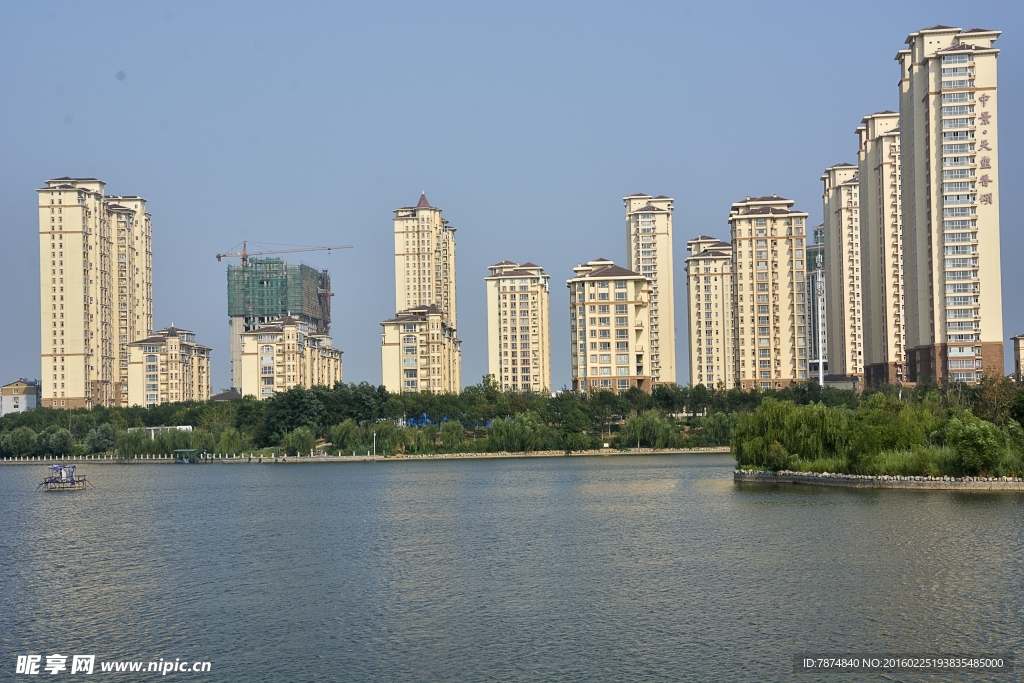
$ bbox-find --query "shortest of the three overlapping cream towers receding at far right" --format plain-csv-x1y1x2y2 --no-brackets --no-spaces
821,164,864,377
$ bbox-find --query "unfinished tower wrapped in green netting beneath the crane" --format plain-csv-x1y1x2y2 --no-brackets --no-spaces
227,257,331,387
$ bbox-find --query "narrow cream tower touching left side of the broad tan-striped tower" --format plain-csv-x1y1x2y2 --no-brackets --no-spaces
686,239,737,389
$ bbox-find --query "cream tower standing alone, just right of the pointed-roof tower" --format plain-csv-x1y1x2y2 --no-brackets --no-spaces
484,261,551,392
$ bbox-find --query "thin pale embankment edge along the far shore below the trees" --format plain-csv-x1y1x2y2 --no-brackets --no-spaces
0,446,729,465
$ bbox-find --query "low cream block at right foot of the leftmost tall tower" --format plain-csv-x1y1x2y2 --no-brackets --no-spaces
128,324,211,408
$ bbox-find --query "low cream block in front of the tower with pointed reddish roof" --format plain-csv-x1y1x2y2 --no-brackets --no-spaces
381,304,462,393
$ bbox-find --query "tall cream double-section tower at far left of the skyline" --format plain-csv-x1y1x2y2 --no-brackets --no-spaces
37,177,153,409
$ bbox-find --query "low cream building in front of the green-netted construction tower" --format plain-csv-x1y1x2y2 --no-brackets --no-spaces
238,315,342,400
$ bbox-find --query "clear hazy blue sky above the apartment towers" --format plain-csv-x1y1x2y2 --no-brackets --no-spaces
0,1,1024,390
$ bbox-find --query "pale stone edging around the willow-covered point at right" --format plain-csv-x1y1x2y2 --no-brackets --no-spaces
732,470,1024,490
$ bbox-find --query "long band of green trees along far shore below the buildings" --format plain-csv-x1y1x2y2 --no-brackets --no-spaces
0,377,1024,463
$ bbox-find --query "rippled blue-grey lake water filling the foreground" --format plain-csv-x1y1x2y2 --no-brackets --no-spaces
0,455,1024,682
